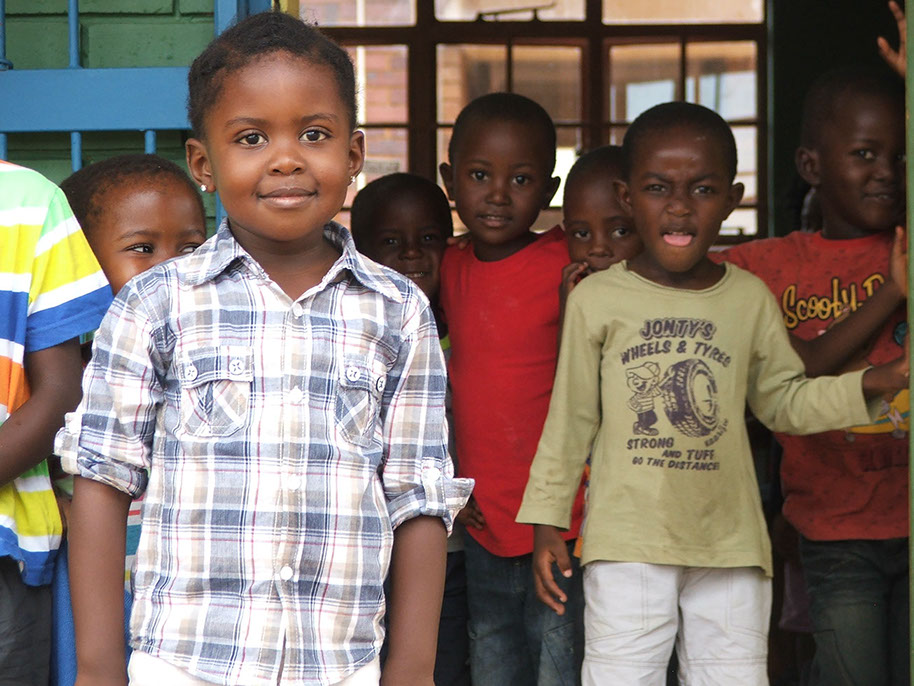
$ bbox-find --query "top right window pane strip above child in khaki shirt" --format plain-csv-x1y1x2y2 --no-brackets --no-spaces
603,0,765,24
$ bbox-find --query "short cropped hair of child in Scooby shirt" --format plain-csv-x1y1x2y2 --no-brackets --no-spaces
800,66,904,148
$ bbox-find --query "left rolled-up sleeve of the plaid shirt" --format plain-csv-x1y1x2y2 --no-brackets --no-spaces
55,287,162,498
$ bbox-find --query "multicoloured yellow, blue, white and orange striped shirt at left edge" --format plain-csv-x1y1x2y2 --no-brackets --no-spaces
0,162,111,586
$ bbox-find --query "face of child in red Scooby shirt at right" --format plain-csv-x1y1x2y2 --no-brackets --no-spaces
797,96,905,238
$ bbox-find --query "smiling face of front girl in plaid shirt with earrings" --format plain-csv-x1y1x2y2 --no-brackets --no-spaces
187,53,364,261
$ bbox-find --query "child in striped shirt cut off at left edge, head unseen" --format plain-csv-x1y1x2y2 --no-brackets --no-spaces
0,162,111,686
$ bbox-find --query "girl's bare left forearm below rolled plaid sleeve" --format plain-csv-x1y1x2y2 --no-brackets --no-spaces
69,476,130,686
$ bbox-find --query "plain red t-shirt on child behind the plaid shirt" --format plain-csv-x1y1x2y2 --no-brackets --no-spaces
441,227,581,557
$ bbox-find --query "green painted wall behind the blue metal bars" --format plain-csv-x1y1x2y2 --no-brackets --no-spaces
6,0,214,202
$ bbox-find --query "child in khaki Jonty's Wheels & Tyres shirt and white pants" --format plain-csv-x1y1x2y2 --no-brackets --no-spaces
518,102,907,686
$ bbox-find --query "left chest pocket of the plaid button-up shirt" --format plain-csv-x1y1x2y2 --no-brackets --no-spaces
178,346,254,438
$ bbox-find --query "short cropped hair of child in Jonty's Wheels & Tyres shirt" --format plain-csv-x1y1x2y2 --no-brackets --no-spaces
622,101,737,181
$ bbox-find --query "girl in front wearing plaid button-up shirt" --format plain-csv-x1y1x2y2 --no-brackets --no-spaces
57,12,470,686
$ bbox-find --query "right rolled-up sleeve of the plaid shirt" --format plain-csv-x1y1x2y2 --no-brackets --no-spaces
381,298,473,533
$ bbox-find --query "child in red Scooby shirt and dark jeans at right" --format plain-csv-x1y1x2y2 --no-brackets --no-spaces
722,68,909,686
